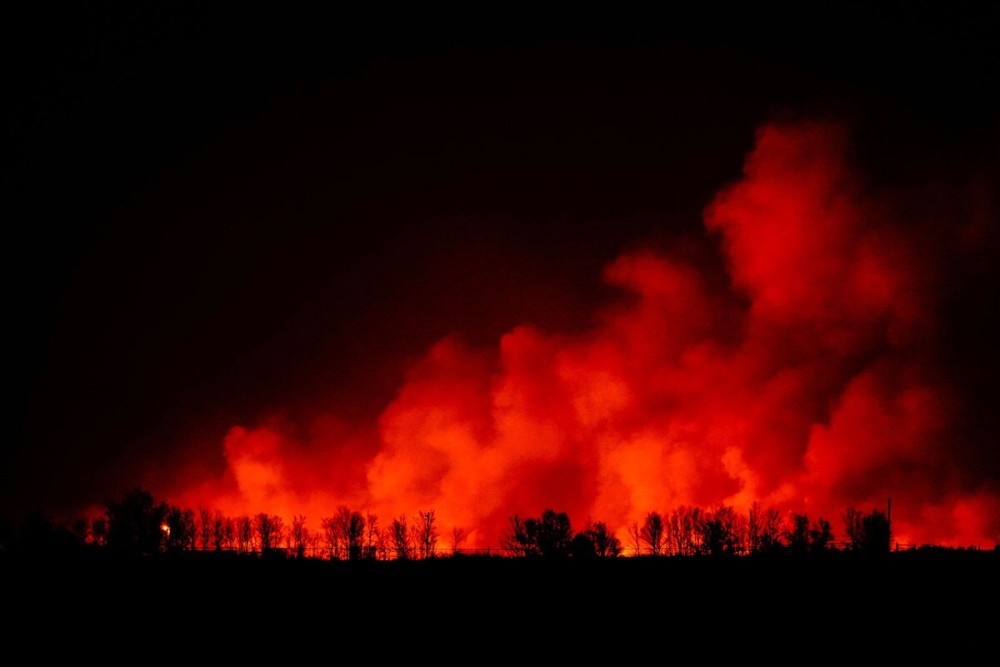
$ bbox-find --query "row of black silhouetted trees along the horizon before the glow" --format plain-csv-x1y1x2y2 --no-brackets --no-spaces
0,488,984,561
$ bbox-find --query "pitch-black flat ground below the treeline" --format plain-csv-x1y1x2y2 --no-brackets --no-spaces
0,551,1000,666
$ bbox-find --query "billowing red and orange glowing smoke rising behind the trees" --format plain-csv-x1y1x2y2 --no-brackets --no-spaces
167,123,1000,547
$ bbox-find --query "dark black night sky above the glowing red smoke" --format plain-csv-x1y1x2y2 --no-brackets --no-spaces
0,3,1000,514
